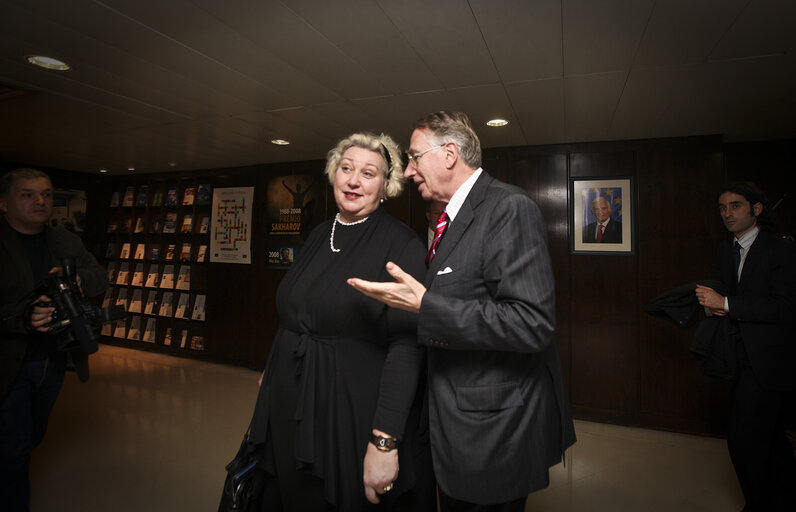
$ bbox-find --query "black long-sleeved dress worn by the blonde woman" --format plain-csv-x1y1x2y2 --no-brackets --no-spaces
252,207,435,511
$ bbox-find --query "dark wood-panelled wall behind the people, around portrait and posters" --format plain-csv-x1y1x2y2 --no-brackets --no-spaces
9,136,796,434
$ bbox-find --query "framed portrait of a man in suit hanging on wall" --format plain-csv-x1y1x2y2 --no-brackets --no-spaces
569,176,636,255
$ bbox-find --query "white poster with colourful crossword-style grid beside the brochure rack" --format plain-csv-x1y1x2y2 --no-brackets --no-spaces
210,187,254,263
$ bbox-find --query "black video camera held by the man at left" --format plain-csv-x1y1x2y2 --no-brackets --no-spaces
34,258,124,354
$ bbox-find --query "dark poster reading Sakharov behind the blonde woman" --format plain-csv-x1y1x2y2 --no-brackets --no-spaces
266,174,326,268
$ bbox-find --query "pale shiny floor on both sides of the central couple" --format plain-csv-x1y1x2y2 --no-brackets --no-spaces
26,346,743,512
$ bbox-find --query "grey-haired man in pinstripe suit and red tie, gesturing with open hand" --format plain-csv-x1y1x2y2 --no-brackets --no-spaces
349,112,575,512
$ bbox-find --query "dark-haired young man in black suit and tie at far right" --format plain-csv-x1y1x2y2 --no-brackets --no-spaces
696,182,796,512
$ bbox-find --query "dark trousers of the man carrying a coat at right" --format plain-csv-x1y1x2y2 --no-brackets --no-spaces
727,365,796,512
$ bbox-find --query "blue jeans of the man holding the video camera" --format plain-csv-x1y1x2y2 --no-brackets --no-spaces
0,355,66,512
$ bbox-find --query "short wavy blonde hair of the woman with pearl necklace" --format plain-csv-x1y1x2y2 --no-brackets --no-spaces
324,132,405,197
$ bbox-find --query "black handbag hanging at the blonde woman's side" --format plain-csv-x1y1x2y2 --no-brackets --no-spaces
218,431,265,512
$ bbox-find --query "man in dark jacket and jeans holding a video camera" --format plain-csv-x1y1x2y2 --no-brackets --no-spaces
0,169,108,512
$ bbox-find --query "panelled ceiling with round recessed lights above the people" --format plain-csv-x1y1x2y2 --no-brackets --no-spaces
0,0,796,173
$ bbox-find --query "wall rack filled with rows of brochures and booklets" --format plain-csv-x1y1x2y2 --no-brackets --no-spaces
101,178,213,355
